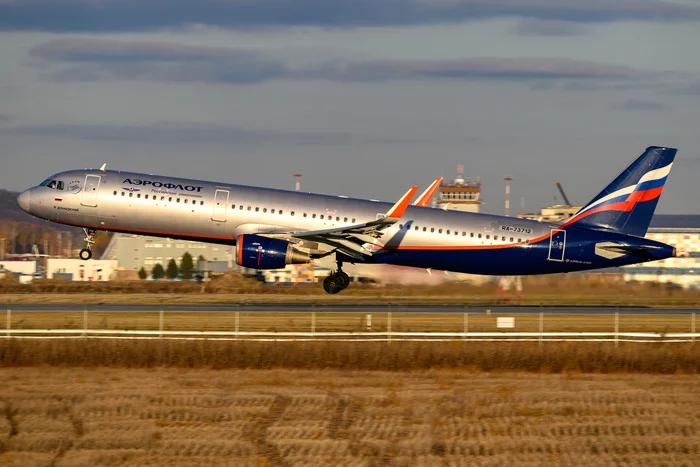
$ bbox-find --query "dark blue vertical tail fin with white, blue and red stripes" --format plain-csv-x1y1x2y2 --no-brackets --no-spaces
562,146,677,237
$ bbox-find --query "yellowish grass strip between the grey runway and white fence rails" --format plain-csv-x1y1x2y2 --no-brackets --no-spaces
0,308,692,332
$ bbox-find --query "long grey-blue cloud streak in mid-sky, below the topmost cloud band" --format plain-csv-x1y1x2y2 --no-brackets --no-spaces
30,39,641,87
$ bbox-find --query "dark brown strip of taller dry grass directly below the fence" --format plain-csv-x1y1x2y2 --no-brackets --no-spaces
0,338,700,374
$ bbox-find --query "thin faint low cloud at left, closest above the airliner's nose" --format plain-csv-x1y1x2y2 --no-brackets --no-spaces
0,122,424,146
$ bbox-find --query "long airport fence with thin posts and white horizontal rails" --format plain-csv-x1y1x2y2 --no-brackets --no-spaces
0,306,700,343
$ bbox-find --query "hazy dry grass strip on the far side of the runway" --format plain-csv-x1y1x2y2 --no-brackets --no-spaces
0,273,700,307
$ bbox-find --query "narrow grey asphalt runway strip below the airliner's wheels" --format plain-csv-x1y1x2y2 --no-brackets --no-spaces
0,303,698,316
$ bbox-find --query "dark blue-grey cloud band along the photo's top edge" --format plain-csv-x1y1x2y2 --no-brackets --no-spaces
0,0,700,32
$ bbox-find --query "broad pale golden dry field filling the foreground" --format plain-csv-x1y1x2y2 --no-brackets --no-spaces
0,367,700,467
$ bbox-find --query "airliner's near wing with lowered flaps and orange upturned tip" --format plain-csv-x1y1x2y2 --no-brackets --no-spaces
257,186,418,259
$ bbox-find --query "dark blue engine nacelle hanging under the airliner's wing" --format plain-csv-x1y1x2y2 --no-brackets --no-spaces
236,234,310,269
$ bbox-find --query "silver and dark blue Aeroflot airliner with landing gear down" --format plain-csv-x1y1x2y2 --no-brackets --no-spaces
17,147,676,293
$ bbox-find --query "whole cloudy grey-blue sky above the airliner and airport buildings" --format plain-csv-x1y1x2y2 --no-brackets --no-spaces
0,0,700,214
